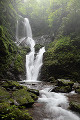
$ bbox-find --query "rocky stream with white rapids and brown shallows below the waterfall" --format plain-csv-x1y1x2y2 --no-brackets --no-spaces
23,82,80,120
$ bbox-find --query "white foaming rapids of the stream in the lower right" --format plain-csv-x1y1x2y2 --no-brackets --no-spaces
38,88,80,120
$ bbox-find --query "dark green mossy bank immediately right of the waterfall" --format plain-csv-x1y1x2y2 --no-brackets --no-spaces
41,37,80,81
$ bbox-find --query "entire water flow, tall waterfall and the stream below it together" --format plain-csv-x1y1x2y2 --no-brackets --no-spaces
16,18,80,120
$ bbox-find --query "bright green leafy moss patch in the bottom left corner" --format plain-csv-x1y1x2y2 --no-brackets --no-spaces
0,104,32,120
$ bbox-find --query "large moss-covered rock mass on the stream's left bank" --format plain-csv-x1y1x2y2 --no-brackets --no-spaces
0,79,38,120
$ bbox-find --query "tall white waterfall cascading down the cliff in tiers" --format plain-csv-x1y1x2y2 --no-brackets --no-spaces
16,18,45,81
